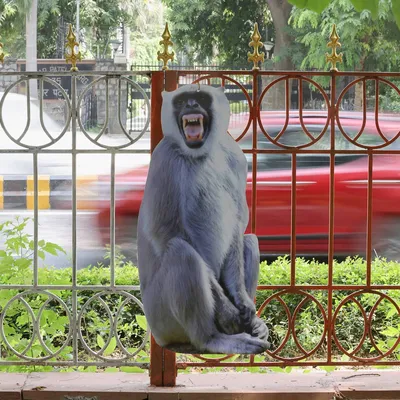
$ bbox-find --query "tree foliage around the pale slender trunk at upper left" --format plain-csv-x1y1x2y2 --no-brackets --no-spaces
0,0,144,58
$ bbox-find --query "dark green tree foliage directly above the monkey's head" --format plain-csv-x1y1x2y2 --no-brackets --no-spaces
164,0,272,66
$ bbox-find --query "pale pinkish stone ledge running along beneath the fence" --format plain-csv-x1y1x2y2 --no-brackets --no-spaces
0,370,400,400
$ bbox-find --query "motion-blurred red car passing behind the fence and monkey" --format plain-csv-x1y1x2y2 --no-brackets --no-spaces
97,113,400,259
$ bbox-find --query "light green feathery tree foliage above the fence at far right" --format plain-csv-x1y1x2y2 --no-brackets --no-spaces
290,0,400,71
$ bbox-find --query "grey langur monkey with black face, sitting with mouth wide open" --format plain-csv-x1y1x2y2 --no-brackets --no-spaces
138,85,269,354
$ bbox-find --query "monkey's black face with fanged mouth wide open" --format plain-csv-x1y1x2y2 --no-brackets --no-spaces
173,91,212,148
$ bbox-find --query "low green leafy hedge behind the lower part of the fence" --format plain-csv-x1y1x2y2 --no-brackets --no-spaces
0,219,400,371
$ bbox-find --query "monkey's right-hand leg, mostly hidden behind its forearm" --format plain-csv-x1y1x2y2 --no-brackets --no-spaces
243,234,269,340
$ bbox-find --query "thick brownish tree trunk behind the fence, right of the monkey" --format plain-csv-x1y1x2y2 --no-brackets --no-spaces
263,0,294,110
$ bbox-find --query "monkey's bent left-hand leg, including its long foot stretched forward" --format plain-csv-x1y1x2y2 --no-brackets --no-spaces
158,238,266,354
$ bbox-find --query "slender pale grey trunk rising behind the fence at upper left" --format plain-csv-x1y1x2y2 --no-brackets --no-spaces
26,0,38,99
